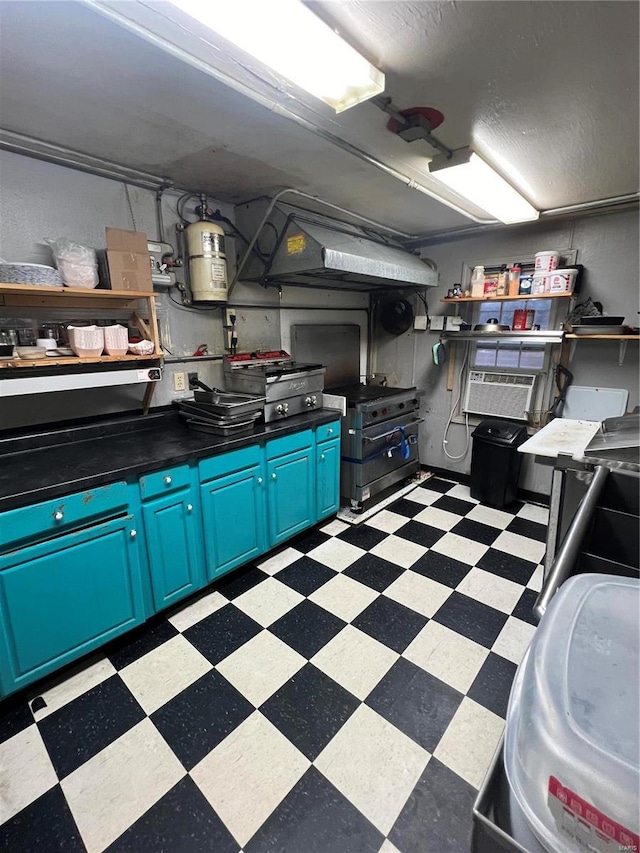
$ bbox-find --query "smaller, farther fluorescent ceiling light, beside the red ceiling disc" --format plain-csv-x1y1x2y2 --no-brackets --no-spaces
429,148,540,225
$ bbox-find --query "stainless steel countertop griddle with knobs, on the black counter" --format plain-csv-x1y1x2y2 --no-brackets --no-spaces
224,350,325,423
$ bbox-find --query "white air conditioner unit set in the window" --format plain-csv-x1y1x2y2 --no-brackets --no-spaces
463,370,536,421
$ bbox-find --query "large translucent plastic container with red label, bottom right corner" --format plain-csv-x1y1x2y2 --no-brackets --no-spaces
504,574,640,853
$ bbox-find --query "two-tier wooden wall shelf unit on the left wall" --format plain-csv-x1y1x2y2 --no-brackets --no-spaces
0,283,162,413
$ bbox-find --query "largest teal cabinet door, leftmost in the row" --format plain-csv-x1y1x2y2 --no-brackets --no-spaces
0,516,145,693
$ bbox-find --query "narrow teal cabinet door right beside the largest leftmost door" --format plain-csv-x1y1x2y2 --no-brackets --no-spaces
142,491,204,610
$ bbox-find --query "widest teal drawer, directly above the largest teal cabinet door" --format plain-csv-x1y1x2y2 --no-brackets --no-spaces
0,482,129,553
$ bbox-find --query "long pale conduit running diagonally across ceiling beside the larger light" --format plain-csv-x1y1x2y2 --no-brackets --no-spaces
84,0,494,226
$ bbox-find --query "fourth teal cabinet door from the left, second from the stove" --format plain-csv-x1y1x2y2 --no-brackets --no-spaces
267,447,316,546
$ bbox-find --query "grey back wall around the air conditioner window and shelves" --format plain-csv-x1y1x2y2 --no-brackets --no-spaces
375,207,639,493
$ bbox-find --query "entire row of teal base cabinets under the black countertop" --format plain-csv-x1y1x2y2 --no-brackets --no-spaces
0,420,340,696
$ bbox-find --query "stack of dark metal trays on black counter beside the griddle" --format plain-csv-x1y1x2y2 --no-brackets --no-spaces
178,391,265,436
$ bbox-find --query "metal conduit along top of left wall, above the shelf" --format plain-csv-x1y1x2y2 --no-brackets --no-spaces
0,128,173,189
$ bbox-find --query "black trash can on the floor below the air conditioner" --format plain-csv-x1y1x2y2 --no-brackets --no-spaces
471,420,527,509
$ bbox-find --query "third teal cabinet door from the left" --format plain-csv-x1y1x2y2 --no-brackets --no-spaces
200,465,267,580
